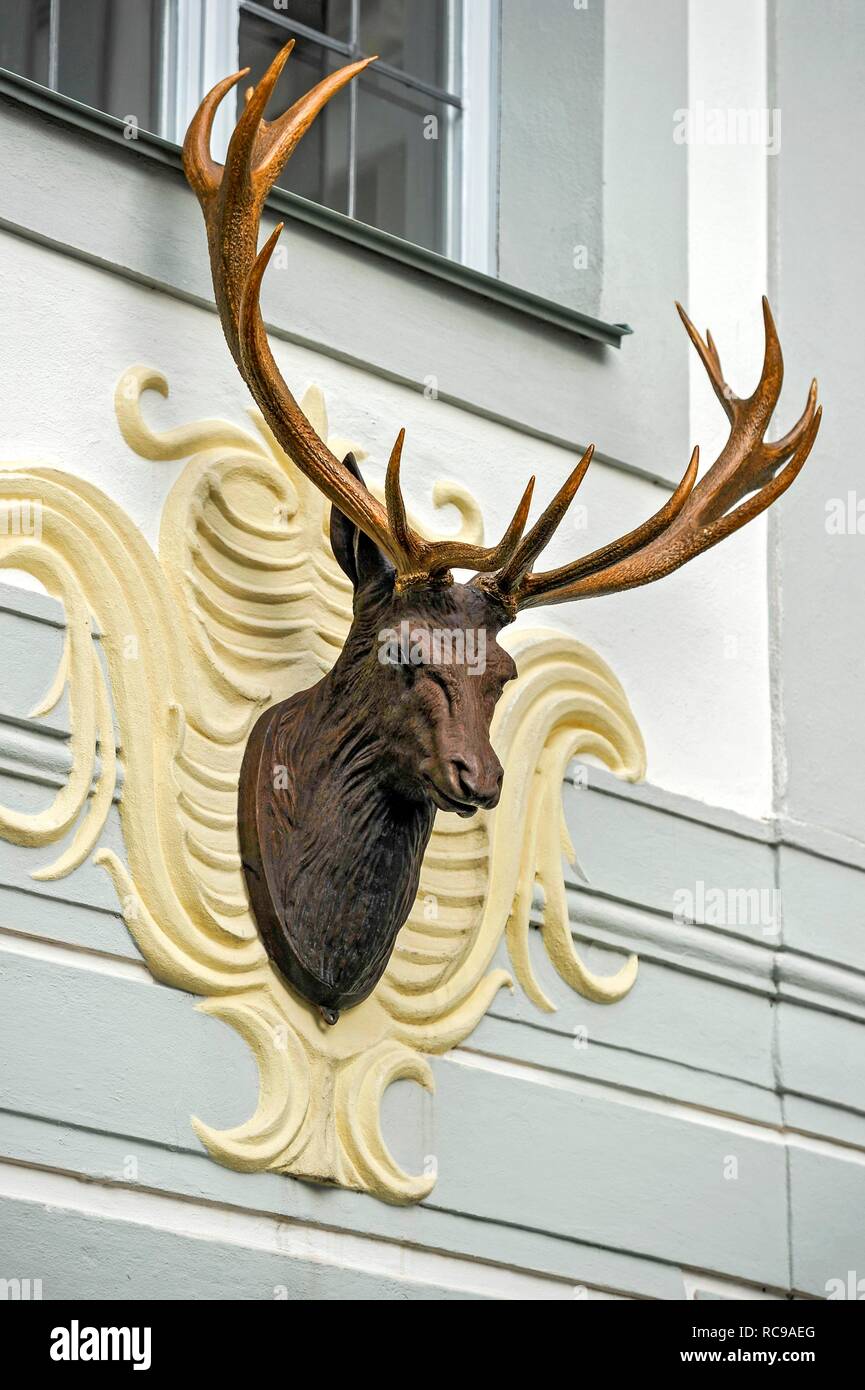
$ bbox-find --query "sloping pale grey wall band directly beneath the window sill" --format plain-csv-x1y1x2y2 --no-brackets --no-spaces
0,93,691,492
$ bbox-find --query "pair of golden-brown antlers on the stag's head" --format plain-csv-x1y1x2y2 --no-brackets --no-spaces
184,48,820,614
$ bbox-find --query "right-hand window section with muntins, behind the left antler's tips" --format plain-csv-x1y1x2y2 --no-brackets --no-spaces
238,0,463,256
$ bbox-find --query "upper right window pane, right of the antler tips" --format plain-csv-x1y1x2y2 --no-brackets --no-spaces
360,0,450,88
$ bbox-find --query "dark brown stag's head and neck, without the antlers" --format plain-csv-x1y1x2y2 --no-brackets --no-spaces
239,483,516,1022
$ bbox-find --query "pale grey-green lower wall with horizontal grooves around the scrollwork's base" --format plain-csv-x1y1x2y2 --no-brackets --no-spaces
0,588,865,1300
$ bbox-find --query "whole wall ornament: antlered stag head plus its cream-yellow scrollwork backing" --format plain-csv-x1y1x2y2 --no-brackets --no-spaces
0,49,819,1202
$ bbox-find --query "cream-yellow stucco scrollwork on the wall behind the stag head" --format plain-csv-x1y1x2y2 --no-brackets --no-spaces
0,367,645,1202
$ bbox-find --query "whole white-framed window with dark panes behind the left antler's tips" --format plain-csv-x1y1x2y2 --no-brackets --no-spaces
0,0,494,270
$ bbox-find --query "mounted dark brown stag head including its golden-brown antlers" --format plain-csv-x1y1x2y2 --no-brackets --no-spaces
184,43,820,1023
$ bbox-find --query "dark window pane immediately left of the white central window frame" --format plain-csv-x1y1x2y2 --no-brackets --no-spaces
57,0,163,131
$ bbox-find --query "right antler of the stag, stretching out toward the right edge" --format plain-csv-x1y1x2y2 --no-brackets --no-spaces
474,297,822,613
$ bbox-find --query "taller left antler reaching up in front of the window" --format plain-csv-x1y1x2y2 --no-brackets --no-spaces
184,39,534,588
